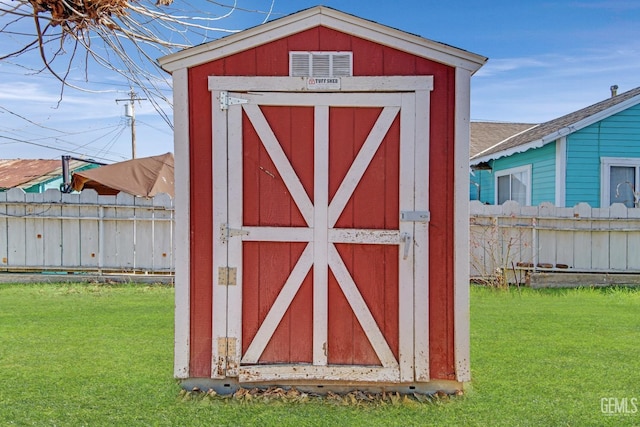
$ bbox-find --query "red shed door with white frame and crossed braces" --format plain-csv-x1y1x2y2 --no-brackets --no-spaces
209,77,432,383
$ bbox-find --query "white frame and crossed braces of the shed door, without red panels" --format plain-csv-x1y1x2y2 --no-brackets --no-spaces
209,76,433,383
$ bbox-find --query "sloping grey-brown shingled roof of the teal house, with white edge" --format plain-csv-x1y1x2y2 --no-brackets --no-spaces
471,87,640,165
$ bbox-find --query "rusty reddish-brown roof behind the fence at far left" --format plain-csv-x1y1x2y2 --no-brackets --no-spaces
0,159,85,189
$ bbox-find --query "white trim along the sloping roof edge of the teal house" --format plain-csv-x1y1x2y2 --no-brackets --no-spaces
469,95,640,166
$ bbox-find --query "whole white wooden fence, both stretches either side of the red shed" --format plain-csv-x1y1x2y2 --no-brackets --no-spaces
6,189,640,277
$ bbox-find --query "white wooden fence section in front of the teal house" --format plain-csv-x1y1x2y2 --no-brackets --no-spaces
470,201,640,277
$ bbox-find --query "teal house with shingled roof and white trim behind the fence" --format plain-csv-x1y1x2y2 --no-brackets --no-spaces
470,86,640,207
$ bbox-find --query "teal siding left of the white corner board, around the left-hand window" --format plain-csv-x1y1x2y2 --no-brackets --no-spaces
470,142,556,205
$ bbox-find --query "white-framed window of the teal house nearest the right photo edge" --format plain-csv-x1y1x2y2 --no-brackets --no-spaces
601,157,640,208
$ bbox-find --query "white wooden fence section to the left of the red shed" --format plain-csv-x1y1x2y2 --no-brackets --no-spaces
0,189,174,273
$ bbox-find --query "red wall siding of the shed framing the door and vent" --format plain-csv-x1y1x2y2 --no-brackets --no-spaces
189,27,455,379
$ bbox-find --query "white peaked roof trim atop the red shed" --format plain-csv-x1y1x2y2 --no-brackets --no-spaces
158,6,487,73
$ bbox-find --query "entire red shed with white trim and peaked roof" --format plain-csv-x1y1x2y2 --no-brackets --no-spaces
160,7,486,392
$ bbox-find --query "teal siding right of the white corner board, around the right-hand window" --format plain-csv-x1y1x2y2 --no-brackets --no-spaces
566,105,640,207
